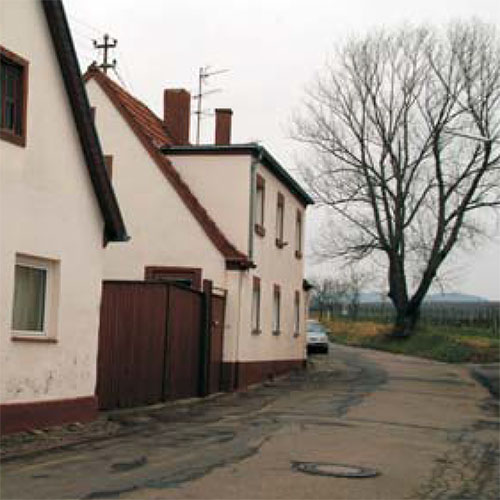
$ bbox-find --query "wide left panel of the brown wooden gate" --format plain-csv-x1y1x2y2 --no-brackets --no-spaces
96,282,169,409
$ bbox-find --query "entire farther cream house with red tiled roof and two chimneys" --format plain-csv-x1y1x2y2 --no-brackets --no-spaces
85,66,312,390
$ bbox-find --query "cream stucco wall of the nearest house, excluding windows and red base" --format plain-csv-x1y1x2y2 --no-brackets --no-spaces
0,0,103,403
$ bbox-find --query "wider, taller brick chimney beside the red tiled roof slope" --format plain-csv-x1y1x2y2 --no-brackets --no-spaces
163,89,191,145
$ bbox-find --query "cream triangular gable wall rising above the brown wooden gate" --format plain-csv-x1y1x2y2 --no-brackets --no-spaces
86,80,226,288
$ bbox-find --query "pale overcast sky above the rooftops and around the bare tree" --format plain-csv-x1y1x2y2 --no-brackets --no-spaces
64,0,500,300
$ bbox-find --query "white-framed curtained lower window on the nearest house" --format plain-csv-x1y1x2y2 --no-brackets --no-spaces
12,255,57,336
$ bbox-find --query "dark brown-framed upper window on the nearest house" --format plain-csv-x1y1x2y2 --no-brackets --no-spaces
0,46,28,146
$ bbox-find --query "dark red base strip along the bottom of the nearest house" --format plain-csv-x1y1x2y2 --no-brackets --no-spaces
0,396,97,434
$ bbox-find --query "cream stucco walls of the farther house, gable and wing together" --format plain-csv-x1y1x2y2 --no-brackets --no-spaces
86,70,305,376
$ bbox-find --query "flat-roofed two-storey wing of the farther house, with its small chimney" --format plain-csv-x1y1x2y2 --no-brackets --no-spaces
162,143,313,387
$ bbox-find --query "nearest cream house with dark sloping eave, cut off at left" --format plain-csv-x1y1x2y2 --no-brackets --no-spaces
0,0,127,432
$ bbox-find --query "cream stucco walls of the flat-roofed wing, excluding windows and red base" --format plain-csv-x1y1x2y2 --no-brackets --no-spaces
170,150,305,361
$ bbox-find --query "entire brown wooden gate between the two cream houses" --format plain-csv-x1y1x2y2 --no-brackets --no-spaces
96,281,225,409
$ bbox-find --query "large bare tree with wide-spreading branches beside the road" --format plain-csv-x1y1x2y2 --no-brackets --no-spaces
293,21,500,336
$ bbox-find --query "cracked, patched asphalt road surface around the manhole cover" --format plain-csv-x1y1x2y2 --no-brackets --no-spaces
0,345,500,500
